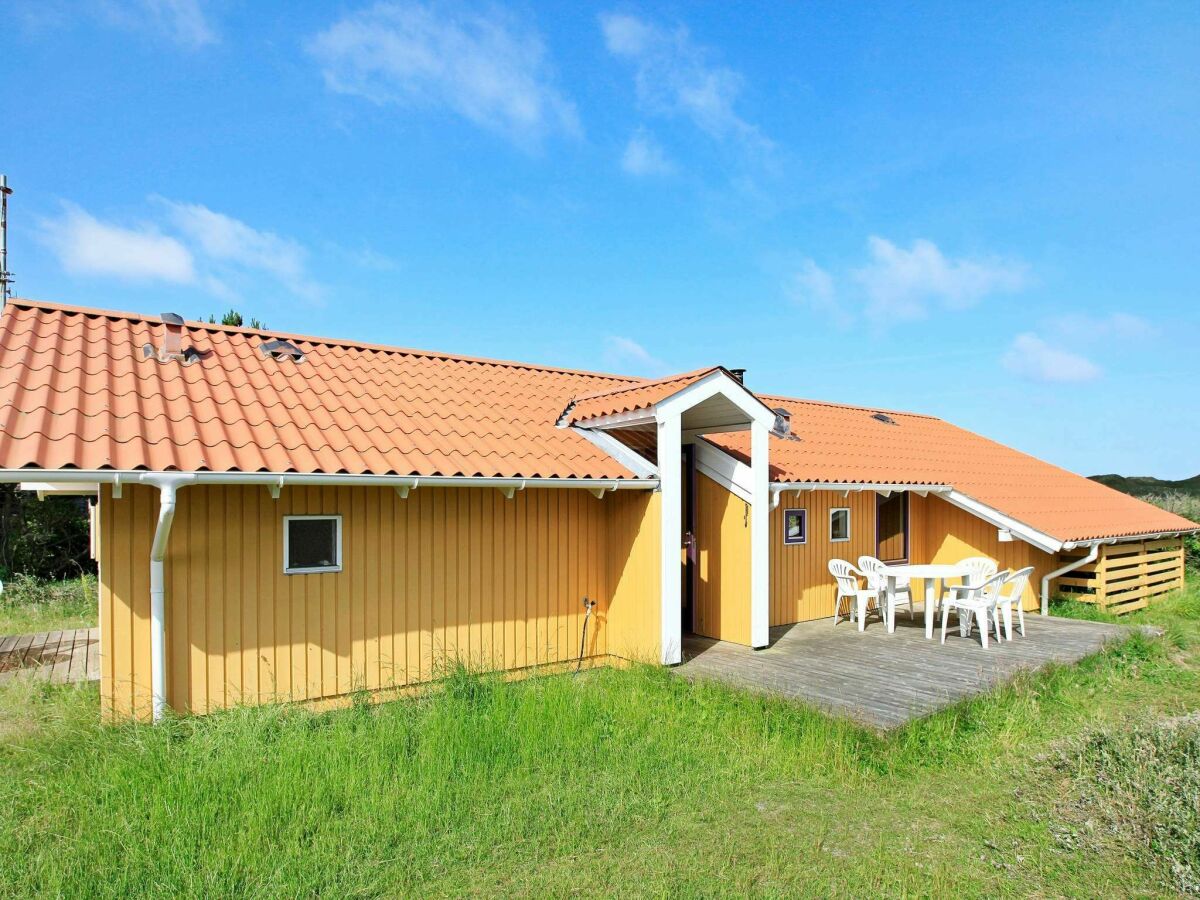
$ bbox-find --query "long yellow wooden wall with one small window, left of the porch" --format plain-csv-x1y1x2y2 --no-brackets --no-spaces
100,486,660,716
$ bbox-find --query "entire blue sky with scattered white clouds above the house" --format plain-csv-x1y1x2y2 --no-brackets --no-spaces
0,0,1200,478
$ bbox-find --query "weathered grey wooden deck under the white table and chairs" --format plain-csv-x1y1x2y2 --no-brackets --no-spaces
674,611,1132,728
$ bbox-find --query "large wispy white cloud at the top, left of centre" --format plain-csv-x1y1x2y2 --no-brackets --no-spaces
308,2,580,148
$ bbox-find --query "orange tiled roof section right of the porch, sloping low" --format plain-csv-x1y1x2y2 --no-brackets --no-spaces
708,397,1200,541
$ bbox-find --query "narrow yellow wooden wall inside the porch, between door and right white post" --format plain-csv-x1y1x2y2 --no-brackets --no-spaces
692,474,750,647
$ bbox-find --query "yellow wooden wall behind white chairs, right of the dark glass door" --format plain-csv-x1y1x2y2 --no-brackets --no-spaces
908,494,1058,610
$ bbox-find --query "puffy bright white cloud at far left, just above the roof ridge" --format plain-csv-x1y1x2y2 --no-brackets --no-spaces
41,203,196,284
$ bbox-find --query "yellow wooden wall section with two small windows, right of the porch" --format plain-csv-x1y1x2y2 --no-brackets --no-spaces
770,491,875,625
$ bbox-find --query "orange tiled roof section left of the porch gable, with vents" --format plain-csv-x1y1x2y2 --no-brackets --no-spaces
0,300,638,478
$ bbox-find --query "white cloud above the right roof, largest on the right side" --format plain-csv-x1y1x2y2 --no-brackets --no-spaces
853,235,1028,323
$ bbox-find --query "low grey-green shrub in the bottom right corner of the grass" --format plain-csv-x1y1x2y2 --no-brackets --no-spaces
1052,713,1200,895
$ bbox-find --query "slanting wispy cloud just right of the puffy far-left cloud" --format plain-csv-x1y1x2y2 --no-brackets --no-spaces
155,197,322,300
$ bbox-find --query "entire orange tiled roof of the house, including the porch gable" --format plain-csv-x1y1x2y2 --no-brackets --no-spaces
0,300,1198,541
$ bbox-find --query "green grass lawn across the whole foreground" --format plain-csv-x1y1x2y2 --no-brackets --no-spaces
0,583,1200,896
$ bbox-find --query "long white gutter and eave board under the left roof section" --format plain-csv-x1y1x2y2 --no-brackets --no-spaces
0,469,659,491
